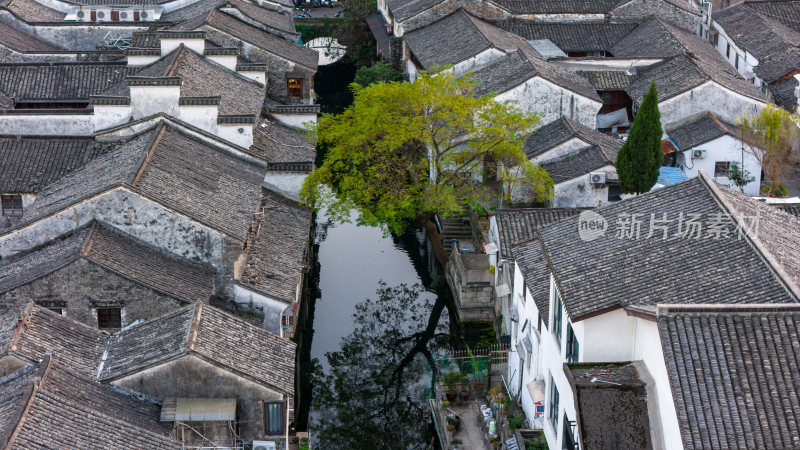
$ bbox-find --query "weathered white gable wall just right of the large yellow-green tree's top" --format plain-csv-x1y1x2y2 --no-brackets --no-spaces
495,77,603,128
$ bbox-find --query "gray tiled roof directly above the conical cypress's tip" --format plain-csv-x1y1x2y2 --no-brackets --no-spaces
611,19,766,103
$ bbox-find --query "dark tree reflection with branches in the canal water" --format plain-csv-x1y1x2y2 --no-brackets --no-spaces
310,281,449,449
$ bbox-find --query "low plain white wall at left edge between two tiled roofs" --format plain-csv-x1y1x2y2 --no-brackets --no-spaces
0,113,94,136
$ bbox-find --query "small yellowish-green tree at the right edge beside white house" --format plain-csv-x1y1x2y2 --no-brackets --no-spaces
740,104,800,195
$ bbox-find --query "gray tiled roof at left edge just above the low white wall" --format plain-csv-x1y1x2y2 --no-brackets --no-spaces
0,62,135,101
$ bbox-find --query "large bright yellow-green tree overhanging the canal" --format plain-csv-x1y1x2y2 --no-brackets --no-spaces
300,71,552,233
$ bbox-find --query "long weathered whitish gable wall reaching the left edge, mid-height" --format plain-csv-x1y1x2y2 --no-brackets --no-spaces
0,188,225,271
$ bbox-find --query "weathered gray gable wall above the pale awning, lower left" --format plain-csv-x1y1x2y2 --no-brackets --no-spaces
113,355,284,441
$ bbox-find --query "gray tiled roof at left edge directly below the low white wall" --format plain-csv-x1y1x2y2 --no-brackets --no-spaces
0,136,111,193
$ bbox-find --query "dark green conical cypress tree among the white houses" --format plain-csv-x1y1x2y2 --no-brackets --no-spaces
616,82,664,194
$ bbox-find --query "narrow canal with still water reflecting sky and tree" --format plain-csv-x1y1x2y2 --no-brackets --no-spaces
295,63,461,450
